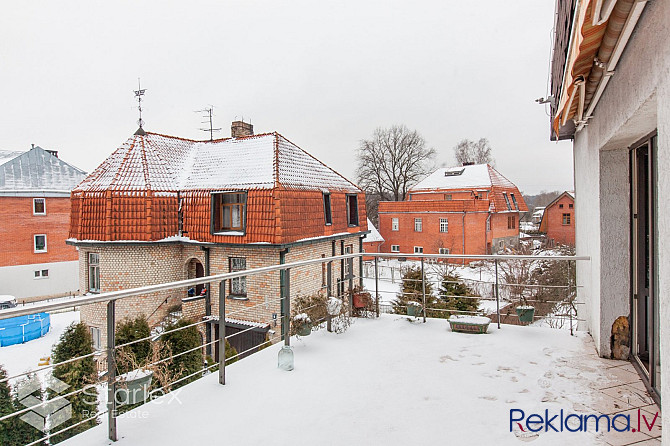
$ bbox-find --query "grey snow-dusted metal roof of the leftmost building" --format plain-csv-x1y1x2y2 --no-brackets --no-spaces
0,146,86,191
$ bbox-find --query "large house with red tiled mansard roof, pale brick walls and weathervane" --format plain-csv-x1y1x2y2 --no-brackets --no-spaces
69,121,367,351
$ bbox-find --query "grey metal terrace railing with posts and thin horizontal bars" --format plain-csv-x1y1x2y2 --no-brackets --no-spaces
0,253,589,445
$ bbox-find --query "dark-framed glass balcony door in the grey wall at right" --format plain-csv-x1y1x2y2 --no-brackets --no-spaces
631,136,661,394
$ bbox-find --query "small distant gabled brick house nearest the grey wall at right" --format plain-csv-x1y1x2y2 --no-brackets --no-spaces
540,191,575,246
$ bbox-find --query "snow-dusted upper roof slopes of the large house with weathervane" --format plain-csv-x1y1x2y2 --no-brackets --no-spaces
76,132,360,192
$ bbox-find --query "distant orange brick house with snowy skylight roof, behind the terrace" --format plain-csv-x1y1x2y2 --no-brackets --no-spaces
379,164,528,254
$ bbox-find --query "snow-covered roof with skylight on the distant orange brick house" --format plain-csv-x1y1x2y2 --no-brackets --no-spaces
410,164,516,192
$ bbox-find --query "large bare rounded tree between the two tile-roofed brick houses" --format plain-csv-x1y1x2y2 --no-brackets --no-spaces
358,125,435,207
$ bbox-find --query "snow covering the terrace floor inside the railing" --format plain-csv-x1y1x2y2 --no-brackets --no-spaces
62,315,606,446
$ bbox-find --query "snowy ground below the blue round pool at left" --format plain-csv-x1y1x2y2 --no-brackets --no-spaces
0,311,79,376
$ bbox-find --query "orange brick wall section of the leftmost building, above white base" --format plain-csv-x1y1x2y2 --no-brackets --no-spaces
0,197,78,266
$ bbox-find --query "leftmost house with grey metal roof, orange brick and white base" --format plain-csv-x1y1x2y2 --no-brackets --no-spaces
0,146,86,298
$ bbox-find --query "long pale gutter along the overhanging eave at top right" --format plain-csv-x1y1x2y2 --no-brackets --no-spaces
575,0,647,132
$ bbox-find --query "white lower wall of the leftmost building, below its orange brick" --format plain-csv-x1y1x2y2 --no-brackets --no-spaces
0,260,79,299
